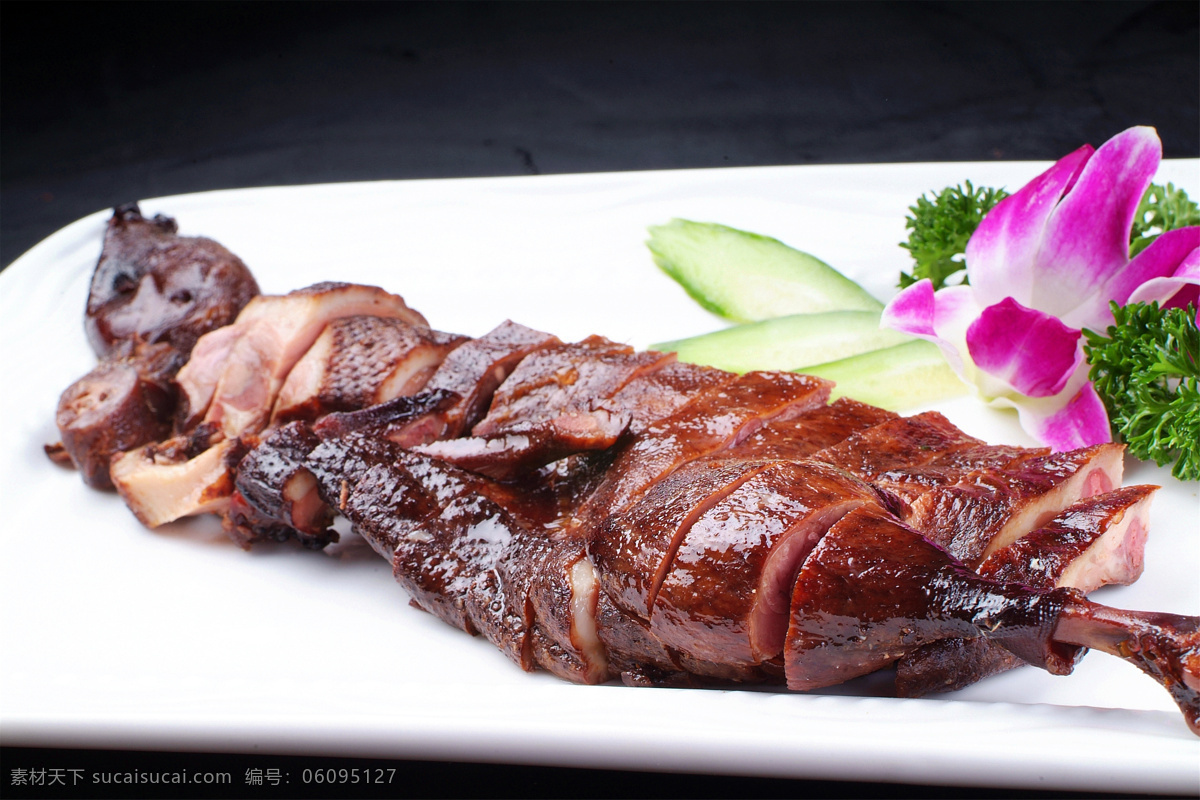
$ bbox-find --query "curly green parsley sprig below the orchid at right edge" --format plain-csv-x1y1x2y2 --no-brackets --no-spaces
1084,302,1200,481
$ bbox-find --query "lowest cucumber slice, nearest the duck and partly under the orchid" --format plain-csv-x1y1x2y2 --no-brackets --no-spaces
803,339,968,411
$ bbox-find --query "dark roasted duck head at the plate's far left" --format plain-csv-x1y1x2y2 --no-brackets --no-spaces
84,203,258,359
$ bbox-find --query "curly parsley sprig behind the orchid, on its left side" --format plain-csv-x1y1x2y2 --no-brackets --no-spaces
900,181,1008,289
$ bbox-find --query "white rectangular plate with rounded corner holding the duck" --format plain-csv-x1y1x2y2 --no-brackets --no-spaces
0,161,1200,792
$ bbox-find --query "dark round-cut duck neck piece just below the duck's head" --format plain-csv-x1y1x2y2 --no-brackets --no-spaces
54,344,181,489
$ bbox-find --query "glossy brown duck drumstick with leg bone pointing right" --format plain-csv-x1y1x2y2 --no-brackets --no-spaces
784,505,1200,735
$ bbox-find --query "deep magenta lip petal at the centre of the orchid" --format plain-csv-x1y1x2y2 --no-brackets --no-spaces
966,297,1084,397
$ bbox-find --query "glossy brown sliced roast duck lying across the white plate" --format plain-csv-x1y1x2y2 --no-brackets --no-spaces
49,209,1200,733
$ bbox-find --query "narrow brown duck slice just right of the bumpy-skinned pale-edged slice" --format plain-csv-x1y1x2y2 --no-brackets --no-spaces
425,321,560,441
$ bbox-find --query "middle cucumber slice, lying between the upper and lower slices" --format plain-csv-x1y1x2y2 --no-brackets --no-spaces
652,311,912,372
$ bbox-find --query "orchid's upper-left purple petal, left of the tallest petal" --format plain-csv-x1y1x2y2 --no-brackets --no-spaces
966,145,1093,305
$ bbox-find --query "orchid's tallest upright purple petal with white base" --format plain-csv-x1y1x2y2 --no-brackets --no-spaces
1032,127,1163,317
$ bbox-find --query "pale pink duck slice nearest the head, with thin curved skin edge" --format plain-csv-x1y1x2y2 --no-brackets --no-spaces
179,283,427,438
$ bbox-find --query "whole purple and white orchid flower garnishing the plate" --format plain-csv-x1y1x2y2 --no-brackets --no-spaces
883,127,1200,450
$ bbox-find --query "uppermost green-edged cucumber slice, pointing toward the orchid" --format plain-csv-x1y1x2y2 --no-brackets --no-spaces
646,219,883,323
